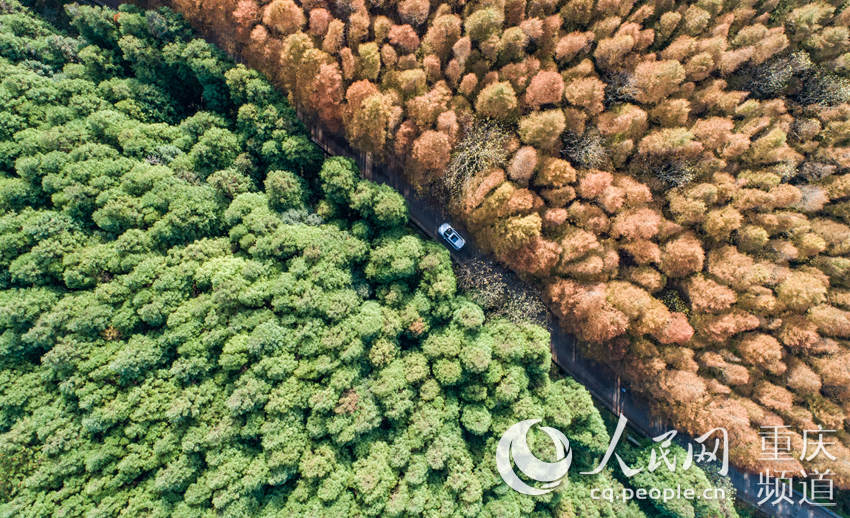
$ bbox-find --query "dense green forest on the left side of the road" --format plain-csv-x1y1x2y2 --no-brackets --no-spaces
0,0,738,518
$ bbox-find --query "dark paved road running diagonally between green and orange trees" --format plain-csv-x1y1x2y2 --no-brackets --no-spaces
81,0,840,518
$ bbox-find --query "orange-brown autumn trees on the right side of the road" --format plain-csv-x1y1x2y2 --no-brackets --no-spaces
156,0,850,486
